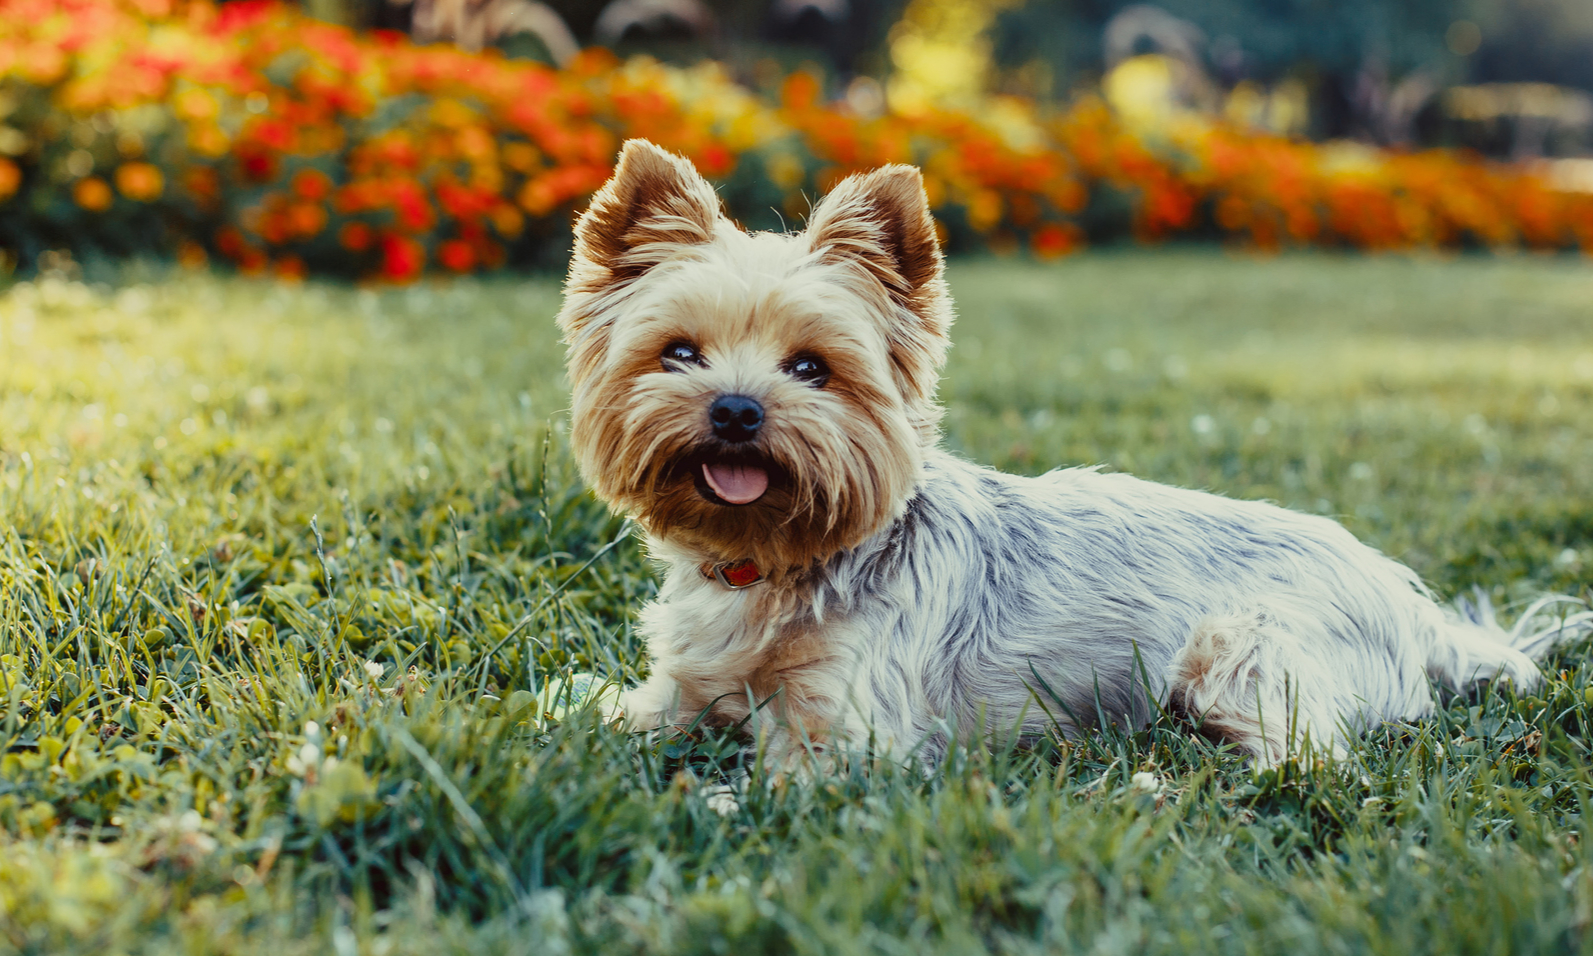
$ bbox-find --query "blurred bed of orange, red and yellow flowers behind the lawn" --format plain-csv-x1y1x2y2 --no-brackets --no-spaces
0,0,1593,282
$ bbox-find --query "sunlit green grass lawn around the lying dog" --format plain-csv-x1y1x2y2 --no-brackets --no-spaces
0,252,1593,956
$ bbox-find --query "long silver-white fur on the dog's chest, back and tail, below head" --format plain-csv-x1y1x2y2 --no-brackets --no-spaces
626,451,1588,763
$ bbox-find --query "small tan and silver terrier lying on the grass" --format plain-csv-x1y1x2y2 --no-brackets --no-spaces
558,140,1590,766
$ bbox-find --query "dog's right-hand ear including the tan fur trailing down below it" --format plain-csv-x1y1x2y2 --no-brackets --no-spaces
808,166,951,400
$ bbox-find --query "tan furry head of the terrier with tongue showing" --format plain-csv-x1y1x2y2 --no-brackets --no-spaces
559,140,951,570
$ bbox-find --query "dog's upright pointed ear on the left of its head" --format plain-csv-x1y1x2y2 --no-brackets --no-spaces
570,139,718,282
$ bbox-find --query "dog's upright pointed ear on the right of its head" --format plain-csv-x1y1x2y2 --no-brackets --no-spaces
808,166,945,317
